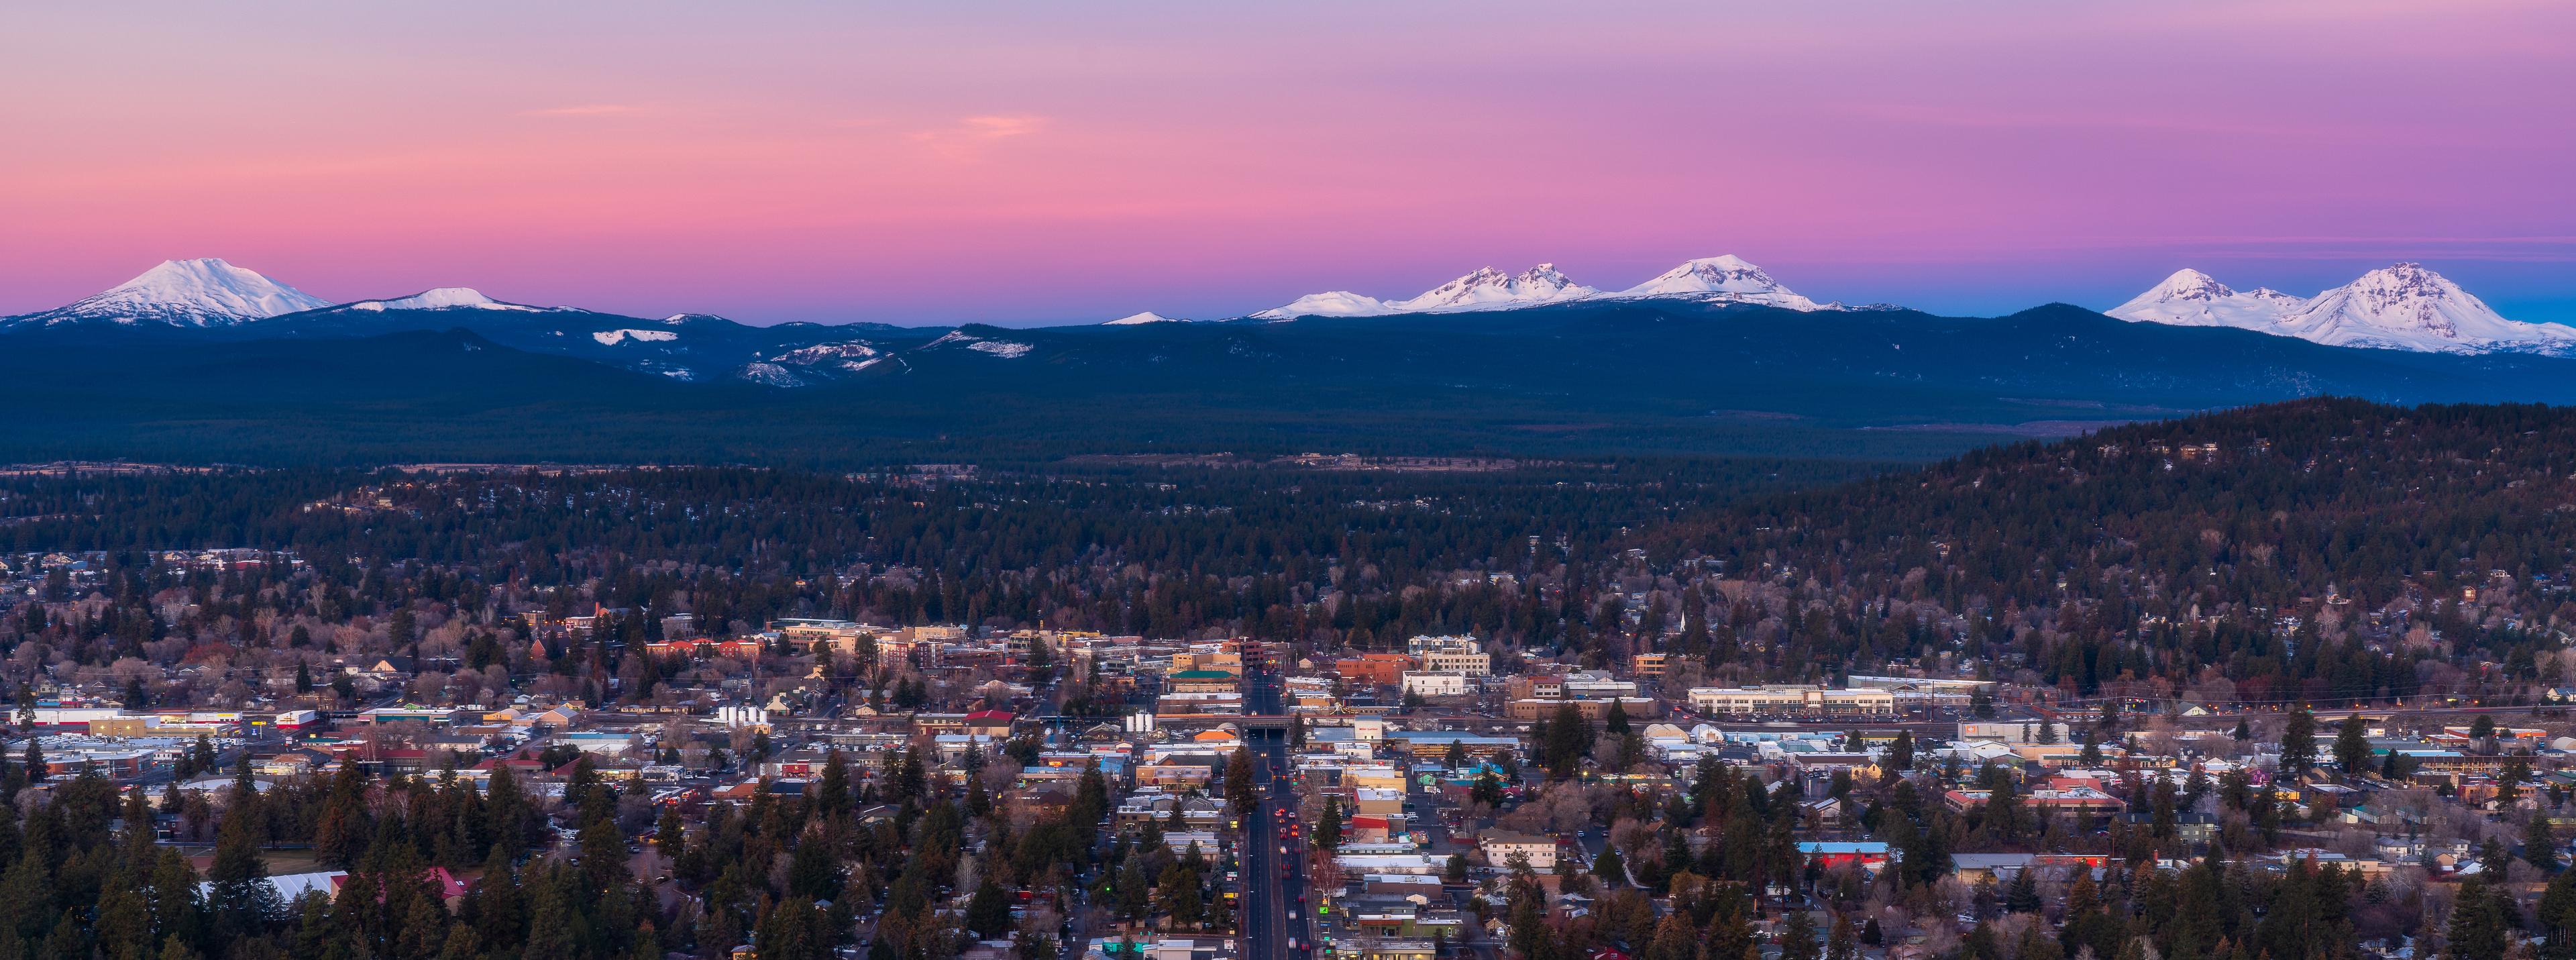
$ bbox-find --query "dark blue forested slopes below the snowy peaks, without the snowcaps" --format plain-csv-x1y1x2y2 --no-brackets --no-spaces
15,301,2576,468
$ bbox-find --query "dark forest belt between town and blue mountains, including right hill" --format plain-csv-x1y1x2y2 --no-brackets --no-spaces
0,399,2576,702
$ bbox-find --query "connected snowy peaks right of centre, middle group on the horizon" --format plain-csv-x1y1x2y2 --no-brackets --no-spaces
1249,255,1847,319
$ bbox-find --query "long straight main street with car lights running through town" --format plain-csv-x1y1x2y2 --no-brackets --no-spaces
1242,656,1313,960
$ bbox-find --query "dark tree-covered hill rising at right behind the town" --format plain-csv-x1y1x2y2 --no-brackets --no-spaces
1656,399,2576,700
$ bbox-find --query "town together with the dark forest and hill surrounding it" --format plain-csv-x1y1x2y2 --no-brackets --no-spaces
0,401,2576,960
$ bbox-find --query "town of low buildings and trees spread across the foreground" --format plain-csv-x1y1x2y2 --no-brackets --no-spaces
0,612,2576,960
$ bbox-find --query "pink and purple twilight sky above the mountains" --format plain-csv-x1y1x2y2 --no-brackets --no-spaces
0,0,2576,324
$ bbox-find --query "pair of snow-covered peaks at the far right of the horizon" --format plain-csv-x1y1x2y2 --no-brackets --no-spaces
2110,262,2576,355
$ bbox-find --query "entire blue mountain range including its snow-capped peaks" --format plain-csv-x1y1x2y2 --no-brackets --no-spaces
0,258,2576,464
